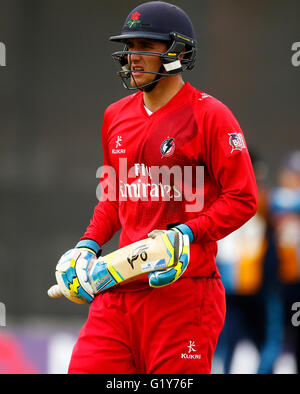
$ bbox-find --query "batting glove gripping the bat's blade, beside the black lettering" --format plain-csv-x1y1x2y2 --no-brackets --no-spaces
148,228,190,288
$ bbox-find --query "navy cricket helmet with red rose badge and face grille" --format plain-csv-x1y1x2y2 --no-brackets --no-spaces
110,1,197,91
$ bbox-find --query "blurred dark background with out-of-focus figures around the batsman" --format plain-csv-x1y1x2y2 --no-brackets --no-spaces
0,0,300,374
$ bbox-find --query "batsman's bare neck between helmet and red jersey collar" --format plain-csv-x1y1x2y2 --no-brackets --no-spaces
143,75,185,112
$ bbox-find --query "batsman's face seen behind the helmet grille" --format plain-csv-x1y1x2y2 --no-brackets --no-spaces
127,38,168,86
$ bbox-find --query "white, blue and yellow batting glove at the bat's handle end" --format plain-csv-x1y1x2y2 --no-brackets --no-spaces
55,248,97,304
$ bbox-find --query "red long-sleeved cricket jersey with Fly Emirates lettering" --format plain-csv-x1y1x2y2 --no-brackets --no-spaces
81,83,257,288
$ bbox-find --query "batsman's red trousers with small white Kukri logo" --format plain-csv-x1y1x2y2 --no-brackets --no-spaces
69,278,225,374
